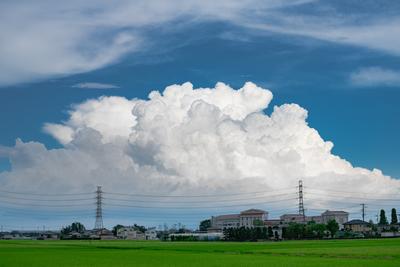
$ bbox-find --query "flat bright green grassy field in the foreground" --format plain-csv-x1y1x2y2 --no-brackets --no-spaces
0,239,400,267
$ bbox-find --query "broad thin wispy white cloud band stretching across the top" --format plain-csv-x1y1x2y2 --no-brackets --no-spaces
0,0,400,86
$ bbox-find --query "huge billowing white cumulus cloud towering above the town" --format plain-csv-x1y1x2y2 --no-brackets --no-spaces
0,82,400,211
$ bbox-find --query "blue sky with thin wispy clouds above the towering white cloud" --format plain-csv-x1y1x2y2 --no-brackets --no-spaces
0,1,400,230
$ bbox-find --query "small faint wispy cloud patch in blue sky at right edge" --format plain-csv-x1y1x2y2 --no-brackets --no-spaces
350,67,400,87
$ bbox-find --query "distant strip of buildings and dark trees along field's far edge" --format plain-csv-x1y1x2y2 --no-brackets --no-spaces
0,208,400,241
